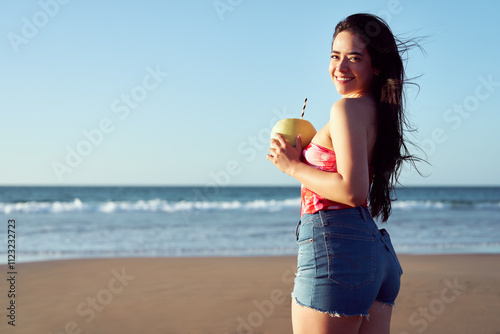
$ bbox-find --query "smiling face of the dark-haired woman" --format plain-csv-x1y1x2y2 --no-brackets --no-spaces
329,30,376,97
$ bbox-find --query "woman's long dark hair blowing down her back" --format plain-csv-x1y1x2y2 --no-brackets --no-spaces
333,14,421,222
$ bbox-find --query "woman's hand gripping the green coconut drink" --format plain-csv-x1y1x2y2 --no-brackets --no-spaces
267,133,302,176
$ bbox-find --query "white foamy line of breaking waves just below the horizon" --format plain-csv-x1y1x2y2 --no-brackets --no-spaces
0,198,500,214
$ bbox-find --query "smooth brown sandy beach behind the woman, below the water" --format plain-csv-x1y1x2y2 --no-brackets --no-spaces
0,255,500,334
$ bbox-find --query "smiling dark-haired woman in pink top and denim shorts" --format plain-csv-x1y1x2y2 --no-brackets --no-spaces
267,14,415,334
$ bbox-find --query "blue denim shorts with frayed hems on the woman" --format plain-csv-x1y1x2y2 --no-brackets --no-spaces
292,206,403,316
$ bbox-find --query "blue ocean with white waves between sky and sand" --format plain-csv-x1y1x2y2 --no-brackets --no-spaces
0,186,500,264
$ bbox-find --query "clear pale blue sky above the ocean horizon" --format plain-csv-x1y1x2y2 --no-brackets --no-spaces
0,0,500,186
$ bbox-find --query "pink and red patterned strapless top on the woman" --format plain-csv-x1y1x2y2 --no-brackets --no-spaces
300,143,368,216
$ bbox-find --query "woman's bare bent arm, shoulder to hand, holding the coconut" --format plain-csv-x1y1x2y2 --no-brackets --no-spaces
268,99,375,206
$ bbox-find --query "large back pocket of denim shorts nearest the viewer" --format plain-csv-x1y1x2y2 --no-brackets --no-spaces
324,233,376,289
